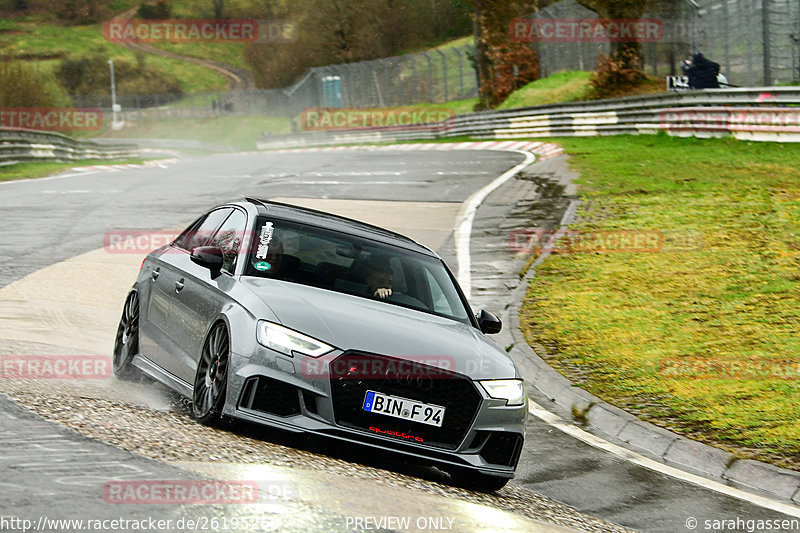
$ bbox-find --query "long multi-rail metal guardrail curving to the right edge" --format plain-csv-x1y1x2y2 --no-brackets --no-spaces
257,87,800,150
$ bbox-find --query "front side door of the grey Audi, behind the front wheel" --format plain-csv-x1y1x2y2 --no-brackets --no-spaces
170,208,247,383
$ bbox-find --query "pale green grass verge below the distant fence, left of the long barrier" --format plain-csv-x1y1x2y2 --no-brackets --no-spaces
104,115,291,150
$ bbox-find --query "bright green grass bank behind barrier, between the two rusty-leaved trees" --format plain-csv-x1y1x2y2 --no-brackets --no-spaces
498,71,591,109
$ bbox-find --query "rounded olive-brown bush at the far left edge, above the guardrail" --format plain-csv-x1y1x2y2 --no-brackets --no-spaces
0,62,72,108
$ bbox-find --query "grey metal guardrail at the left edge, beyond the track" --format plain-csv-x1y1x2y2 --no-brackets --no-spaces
0,128,137,164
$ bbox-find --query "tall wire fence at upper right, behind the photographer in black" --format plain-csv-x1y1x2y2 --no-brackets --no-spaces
532,0,800,87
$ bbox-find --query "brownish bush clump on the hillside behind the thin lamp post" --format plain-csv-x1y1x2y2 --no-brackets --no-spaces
55,54,183,96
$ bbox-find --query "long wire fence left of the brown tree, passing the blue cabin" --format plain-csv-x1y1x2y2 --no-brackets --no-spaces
73,45,478,120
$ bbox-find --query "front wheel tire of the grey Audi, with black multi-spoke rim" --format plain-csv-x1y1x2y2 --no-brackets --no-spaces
192,322,231,426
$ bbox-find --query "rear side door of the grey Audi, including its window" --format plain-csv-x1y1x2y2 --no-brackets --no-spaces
150,207,233,383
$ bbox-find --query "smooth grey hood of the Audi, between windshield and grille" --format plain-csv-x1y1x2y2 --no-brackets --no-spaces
242,277,517,379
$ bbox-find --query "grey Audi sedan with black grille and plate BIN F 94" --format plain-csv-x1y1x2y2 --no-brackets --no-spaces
114,198,527,490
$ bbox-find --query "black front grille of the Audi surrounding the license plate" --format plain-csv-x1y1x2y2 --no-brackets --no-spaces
330,351,481,450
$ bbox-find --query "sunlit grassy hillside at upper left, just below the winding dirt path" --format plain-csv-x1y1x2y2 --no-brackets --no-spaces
0,21,226,92
